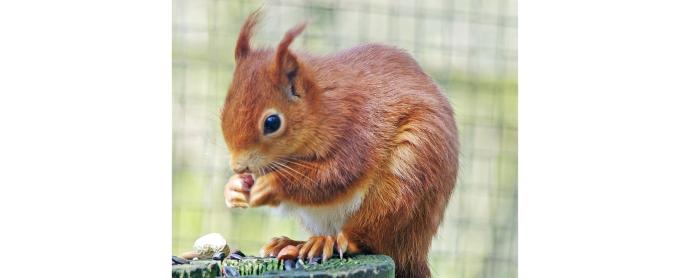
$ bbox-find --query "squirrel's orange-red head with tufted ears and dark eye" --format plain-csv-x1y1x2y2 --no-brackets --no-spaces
221,11,321,174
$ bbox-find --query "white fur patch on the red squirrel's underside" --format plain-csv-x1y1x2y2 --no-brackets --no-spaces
278,192,364,235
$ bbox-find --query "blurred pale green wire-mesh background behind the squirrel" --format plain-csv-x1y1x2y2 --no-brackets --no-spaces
172,0,517,277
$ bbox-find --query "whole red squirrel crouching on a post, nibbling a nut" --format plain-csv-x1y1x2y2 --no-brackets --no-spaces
221,11,459,277
